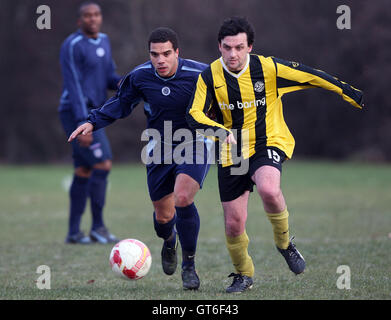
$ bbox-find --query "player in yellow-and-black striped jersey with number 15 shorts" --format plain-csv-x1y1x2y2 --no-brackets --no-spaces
187,17,363,293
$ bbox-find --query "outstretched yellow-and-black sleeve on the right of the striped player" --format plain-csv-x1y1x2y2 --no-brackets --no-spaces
273,58,364,109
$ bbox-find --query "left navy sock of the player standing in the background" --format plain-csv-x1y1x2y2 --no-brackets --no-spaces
68,175,89,235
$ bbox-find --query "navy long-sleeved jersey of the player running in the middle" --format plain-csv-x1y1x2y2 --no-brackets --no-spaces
89,58,207,137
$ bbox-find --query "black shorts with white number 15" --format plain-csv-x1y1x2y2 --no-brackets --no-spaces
218,147,286,202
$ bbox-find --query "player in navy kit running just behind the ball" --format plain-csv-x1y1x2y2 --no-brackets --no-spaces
69,28,213,289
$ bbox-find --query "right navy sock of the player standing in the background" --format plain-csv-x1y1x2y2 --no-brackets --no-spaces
89,169,110,230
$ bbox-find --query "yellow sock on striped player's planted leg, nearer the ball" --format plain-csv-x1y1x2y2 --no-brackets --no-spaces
225,231,254,277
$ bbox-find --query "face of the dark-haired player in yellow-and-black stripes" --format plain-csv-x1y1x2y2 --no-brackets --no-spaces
219,32,253,72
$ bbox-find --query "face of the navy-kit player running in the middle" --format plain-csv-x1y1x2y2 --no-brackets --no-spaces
149,41,179,77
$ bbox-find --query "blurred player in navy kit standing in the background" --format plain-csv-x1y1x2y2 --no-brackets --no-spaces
59,2,120,244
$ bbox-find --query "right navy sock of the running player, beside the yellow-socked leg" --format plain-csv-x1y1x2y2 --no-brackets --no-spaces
175,202,200,268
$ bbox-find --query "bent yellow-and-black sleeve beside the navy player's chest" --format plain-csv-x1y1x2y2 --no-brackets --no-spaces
186,68,231,136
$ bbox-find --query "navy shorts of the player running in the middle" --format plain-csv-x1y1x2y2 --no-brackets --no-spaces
146,140,213,201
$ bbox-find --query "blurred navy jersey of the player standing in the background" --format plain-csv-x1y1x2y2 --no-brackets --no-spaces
59,30,120,123
